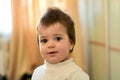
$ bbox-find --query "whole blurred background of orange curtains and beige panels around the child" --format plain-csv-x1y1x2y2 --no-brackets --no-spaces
0,0,120,80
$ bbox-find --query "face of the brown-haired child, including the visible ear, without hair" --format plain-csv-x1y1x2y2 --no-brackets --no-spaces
38,23,73,64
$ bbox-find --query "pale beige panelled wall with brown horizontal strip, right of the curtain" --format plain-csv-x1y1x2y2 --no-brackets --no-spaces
79,0,120,80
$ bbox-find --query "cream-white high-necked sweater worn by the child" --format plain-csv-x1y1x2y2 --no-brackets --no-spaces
31,59,89,80
